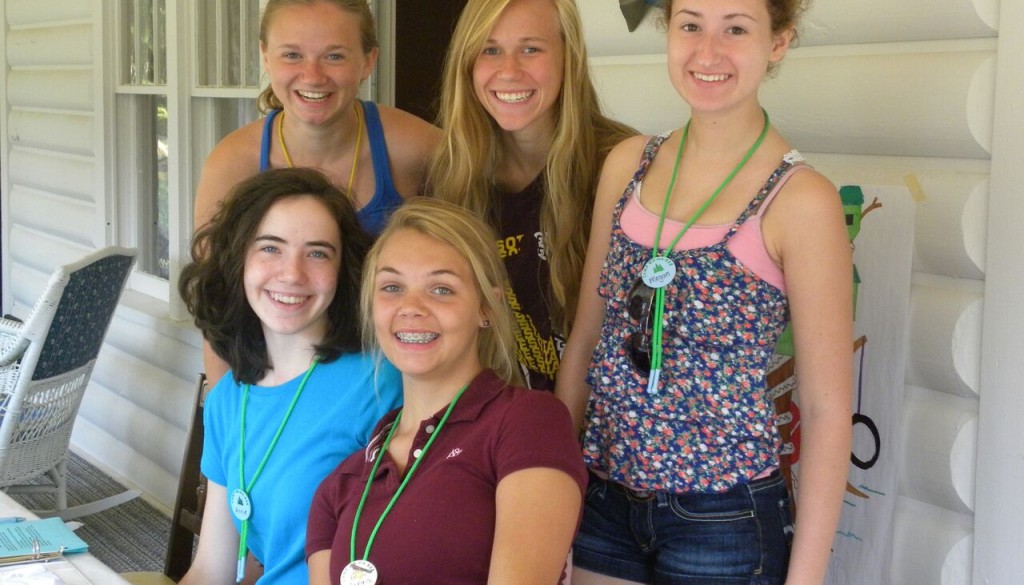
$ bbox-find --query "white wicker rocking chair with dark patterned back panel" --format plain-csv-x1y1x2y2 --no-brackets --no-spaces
0,247,135,511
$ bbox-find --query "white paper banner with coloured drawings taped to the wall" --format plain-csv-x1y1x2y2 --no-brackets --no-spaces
768,185,914,585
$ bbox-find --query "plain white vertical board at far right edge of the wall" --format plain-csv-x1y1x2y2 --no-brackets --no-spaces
972,0,1024,584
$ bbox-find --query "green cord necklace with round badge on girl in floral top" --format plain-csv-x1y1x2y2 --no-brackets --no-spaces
641,109,771,393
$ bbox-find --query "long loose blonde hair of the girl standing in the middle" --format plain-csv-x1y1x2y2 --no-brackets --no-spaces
428,0,636,335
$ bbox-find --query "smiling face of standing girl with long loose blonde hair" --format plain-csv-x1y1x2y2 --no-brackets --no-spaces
473,0,564,140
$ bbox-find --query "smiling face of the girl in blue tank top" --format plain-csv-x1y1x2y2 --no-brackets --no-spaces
260,2,377,124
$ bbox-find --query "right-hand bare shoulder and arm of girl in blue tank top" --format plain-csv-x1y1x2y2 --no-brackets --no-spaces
377,106,441,199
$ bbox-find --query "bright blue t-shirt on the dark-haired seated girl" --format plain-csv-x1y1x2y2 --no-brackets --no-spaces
202,353,401,585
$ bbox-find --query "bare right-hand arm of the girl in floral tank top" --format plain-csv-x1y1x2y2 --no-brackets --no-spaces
765,171,853,585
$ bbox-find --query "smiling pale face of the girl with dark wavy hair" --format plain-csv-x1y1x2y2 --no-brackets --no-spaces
243,195,341,346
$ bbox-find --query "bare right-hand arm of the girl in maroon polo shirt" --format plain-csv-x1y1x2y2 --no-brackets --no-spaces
487,467,583,585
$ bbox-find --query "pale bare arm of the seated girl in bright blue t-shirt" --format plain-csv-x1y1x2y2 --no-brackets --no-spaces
180,482,239,585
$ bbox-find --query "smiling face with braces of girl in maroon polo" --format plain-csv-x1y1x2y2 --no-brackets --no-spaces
372,228,486,386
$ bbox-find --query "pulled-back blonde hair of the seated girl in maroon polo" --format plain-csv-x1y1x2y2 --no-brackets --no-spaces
359,197,521,384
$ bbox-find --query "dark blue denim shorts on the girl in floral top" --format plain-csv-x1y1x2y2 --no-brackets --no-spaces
572,470,794,585
